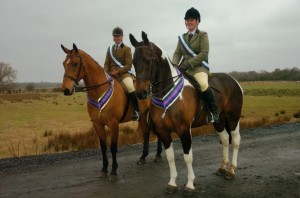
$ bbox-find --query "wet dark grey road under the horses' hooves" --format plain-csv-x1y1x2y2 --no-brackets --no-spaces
0,123,300,198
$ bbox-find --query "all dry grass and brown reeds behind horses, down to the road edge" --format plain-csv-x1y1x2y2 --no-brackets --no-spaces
0,82,300,158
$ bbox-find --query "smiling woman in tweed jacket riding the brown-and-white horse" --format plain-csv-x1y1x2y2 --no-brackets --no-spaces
172,7,220,123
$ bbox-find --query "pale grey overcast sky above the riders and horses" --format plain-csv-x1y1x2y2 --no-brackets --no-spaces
0,0,300,82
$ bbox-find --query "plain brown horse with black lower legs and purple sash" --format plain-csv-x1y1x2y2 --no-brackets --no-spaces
61,44,162,178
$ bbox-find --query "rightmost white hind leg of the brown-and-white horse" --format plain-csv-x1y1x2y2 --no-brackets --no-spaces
231,120,241,173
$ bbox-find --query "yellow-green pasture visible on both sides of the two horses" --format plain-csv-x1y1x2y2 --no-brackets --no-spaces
0,82,300,158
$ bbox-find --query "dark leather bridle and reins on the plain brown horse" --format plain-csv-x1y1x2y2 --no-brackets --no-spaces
64,52,113,92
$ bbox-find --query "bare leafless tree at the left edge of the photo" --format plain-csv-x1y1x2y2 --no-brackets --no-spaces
0,62,17,89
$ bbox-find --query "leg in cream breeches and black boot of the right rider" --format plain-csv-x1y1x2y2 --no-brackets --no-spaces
194,72,220,123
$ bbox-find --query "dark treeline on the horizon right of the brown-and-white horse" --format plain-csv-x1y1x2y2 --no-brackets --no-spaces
228,67,300,81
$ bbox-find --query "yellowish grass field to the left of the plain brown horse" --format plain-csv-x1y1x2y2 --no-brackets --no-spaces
0,93,91,158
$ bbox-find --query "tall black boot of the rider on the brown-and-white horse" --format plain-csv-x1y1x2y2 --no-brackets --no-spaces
202,87,220,124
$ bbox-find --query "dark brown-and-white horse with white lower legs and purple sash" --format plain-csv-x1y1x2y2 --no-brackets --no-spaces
129,32,243,193
